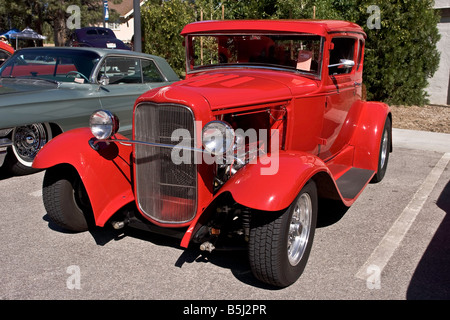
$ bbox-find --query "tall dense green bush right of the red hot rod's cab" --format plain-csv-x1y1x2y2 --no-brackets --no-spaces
355,0,440,105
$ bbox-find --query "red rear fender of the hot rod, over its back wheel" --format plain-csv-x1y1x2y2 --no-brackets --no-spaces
350,102,390,171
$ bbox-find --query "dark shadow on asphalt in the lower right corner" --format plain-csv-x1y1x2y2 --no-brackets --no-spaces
406,181,450,300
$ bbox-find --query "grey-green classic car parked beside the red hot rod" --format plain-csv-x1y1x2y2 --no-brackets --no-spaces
0,48,179,174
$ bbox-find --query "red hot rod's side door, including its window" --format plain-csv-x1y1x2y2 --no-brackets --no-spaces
319,35,360,159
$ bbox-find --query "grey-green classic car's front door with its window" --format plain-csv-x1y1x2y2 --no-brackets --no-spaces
97,56,166,138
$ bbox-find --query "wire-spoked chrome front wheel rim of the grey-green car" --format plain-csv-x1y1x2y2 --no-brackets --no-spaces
13,124,48,166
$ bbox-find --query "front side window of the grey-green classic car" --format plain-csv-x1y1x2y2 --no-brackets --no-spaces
97,57,142,84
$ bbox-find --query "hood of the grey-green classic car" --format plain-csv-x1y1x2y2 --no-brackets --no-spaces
0,78,59,95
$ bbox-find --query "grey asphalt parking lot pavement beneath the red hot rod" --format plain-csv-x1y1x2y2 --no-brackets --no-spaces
0,129,450,304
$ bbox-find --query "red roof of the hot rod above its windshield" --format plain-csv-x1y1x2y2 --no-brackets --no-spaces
181,20,366,36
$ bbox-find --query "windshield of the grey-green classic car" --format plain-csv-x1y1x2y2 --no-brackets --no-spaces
0,49,100,83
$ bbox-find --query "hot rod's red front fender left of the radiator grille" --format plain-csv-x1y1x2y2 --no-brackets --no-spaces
33,128,134,227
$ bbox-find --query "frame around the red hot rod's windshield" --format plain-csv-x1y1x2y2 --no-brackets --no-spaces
185,30,326,80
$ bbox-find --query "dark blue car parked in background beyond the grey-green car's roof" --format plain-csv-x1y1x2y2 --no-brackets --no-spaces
68,27,131,50
